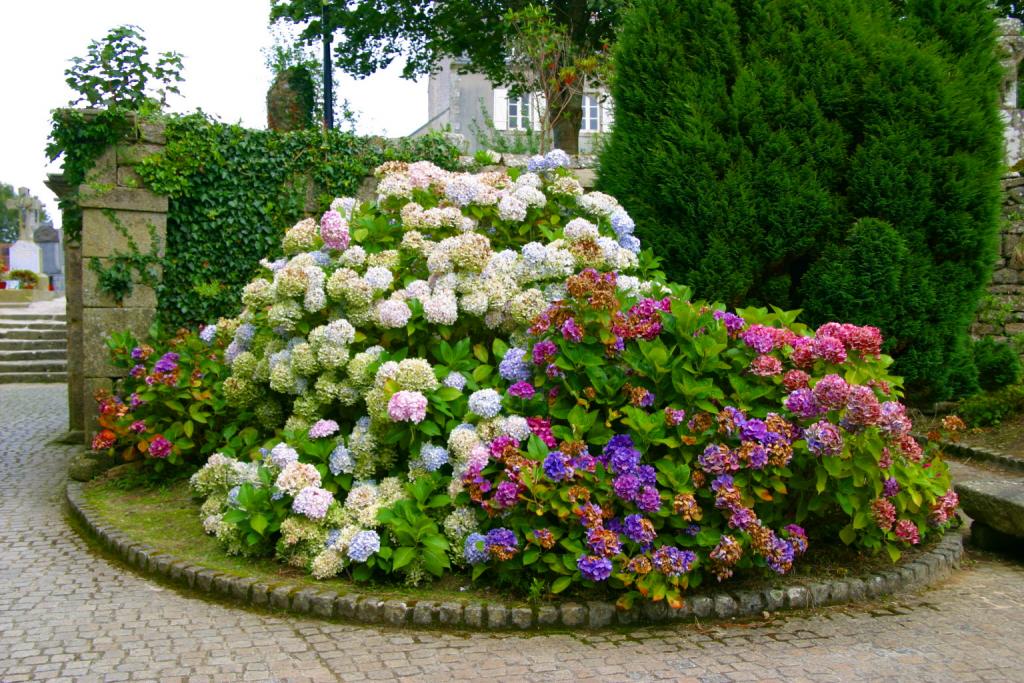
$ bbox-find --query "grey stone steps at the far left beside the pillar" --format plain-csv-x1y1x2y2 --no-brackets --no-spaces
0,307,68,384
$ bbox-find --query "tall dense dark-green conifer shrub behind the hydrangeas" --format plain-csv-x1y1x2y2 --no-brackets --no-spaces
599,0,1002,400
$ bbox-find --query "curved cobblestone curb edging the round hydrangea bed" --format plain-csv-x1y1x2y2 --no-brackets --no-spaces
67,481,964,631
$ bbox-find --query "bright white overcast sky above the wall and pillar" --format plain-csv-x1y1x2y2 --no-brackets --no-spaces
0,0,427,232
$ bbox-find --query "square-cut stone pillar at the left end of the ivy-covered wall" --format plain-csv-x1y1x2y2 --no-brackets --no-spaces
51,116,168,443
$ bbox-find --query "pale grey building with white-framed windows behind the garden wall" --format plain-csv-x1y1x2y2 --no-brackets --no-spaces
412,58,613,154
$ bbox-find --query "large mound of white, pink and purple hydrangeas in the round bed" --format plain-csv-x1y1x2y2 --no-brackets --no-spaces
178,151,956,605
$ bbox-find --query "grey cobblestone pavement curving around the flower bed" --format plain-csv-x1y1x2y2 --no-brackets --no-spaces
0,385,1024,683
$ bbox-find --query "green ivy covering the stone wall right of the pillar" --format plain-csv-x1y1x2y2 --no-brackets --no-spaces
130,114,459,329
